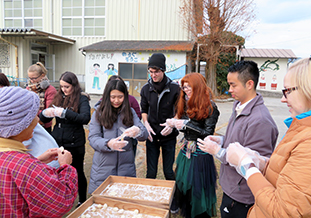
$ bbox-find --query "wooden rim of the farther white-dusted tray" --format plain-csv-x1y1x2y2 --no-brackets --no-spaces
92,176,175,210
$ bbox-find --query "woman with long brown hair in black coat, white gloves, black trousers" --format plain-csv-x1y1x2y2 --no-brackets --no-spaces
40,71,91,206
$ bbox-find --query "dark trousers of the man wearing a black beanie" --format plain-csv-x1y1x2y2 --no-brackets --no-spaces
146,138,176,180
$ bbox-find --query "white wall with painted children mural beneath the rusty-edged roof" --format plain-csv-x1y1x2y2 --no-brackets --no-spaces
85,51,186,94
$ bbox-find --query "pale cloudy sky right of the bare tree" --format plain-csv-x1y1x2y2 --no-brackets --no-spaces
241,0,311,58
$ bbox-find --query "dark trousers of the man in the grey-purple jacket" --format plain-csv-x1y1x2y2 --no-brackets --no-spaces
220,193,253,218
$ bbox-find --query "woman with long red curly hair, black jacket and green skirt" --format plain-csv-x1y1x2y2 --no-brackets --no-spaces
162,73,219,217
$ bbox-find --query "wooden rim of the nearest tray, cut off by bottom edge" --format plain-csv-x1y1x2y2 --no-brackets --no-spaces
67,196,169,218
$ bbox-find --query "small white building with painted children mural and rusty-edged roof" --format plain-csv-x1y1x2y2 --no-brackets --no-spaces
80,40,193,96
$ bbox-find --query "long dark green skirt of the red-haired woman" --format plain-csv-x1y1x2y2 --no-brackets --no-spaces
176,149,217,217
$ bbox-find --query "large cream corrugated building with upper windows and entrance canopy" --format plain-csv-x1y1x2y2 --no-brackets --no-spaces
0,0,191,89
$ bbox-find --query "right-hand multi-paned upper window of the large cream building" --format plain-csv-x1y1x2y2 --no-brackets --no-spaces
62,0,106,36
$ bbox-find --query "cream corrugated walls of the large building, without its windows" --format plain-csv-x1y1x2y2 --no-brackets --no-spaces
0,0,189,80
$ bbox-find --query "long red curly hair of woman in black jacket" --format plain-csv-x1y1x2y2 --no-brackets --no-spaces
176,73,213,120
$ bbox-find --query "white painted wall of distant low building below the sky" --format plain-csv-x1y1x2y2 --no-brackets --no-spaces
244,58,288,91
